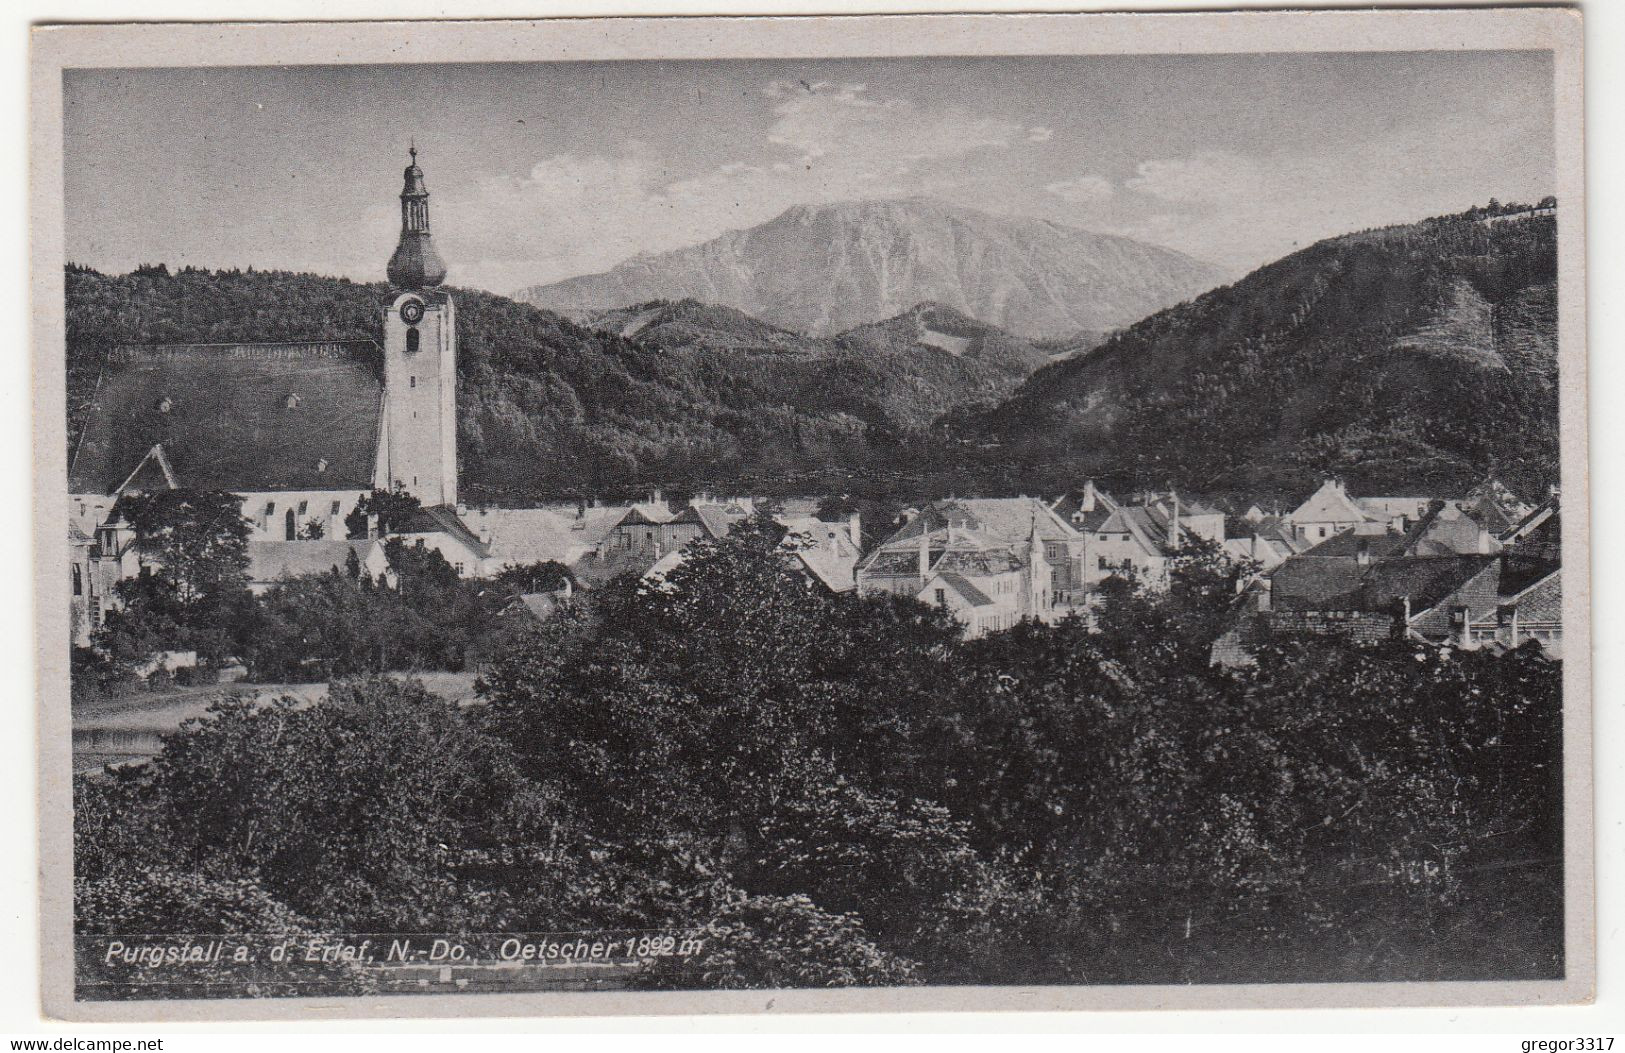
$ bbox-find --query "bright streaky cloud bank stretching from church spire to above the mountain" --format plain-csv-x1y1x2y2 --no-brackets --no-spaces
436,81,1027,291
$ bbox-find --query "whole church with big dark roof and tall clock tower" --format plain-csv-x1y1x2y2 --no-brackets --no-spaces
68,150,468,640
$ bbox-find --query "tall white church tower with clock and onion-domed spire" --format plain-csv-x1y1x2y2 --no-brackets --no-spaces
379,146,457,507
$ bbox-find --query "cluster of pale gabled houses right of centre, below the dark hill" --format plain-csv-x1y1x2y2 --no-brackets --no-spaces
856,479,1562,650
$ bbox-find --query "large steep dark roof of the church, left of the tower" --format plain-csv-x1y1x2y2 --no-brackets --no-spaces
68,341,384,494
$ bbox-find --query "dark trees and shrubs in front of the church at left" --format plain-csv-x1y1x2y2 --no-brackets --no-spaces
73,489,516,702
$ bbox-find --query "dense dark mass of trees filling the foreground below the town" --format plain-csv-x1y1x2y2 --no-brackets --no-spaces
78,518,1563,986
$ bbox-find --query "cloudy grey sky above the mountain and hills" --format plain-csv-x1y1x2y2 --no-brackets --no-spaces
63,52,1554,293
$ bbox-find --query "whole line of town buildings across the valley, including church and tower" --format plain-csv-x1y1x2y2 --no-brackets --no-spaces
68,151,1562,658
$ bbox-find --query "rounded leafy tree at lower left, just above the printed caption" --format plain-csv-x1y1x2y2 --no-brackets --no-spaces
151,678,548,933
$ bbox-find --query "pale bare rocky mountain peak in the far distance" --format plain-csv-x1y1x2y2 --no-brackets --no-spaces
517,197,1219,338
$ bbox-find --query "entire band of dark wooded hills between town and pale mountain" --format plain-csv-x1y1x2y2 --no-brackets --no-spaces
67,203,1557,499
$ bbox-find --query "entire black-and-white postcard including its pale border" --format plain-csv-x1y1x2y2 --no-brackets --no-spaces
34,10,1593,1016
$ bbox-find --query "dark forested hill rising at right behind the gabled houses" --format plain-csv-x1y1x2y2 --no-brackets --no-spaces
956,208,1558,494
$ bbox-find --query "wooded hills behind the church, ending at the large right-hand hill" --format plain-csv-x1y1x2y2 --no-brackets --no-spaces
67,267,1025,501
